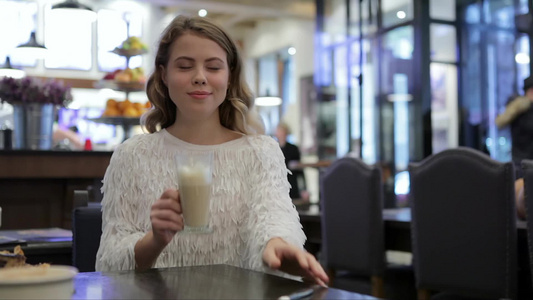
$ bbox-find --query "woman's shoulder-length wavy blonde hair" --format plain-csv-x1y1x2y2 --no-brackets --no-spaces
141,16,264,134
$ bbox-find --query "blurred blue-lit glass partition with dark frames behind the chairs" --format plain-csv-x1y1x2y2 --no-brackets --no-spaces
314,0,531,206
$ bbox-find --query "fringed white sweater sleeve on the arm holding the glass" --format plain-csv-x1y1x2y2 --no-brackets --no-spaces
96,137,145,271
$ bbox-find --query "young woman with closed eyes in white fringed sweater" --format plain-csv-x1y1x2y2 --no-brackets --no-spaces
96,16,328,284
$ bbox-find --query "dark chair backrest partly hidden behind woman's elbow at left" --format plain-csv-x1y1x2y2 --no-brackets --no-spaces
72,192,102,272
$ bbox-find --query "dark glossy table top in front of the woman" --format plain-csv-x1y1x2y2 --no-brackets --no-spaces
73,265,377,299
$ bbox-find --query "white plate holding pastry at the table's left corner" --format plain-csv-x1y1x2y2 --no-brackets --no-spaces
0,266,78,299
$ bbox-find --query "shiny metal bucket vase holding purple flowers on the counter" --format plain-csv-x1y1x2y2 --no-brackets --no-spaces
13,103,56,150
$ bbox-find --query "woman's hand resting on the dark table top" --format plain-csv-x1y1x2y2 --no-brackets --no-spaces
263,238,329,286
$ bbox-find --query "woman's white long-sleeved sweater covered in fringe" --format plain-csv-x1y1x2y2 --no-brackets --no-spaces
96,129,305,274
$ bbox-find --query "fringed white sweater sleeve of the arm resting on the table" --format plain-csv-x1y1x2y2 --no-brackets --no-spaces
243,136,306,271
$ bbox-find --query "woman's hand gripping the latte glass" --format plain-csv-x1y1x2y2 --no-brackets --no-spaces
150,189,183,246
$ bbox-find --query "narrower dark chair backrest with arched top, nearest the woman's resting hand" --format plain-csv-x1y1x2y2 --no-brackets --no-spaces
320,157,385,276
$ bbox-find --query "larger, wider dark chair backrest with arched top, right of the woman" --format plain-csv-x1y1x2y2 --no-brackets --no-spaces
409,147,517,299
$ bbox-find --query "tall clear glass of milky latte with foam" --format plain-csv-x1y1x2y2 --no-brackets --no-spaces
176,152,213,233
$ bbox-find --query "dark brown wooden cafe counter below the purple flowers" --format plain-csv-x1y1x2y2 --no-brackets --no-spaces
0,150,113,229
